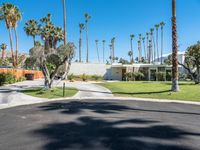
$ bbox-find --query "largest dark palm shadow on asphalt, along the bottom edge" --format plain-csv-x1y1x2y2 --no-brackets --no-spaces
31,117,200,150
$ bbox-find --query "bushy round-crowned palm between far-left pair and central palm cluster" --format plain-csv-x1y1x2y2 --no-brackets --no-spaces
24,20,40,46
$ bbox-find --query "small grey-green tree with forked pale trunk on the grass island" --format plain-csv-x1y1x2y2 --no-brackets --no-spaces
30,43,75,88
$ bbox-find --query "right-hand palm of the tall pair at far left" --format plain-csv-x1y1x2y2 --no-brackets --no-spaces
12,6,22,66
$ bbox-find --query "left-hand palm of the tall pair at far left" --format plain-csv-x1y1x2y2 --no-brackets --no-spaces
0,3,15,67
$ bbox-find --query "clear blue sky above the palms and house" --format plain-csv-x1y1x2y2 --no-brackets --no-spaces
0,0,200,62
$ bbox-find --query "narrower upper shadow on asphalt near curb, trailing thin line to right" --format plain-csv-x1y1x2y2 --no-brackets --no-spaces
39,99,200,116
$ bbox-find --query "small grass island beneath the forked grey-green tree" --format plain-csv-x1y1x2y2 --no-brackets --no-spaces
22,88,78,99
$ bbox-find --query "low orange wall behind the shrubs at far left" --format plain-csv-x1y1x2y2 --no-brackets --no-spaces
0,68,44,79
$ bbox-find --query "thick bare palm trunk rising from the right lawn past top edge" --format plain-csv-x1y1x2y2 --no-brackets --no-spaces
172,0,180,92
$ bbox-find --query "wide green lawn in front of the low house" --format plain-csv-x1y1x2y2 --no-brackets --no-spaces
100,82,200,102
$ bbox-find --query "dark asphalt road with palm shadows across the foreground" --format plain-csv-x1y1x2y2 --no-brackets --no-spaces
0,100,200,150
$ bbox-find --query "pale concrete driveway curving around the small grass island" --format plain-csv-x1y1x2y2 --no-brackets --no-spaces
0,79,113,109
